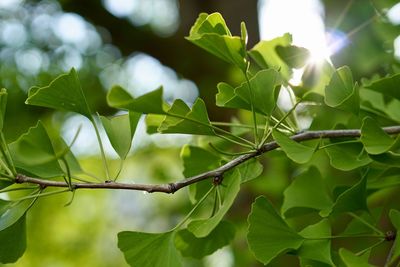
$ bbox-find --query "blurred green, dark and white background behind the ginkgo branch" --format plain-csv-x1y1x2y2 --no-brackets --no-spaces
0,0,400,267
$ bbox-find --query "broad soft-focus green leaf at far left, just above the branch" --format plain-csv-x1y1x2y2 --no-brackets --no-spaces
9,121,64,178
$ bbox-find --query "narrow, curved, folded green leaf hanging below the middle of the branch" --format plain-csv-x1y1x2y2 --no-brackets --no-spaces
187,171,240,238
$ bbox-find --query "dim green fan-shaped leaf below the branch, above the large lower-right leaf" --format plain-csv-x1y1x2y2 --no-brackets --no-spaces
282,166,333,216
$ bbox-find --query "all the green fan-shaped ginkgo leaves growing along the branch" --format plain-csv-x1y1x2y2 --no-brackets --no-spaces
0,13,400,267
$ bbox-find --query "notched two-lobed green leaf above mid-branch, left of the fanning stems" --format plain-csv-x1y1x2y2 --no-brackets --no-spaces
158,98,215,135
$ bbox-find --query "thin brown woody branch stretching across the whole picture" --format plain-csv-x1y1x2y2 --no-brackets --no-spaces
15,126,400,194
